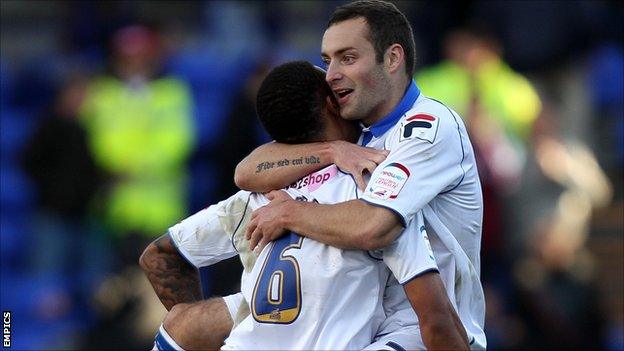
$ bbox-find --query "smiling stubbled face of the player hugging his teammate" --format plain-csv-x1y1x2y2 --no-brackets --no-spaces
321,17,396,125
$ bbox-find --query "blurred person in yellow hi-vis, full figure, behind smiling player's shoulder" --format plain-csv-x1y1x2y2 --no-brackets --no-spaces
416,27,541,270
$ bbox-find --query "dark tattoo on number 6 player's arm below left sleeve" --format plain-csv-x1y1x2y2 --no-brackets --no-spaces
141,235,202,310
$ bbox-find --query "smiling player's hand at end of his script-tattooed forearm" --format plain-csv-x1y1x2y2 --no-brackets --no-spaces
331,140,390,190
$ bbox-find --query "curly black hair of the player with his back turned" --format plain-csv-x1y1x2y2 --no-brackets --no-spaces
256,61,335,144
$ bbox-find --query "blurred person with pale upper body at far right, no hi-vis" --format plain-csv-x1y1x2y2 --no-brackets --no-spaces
512,104,612,350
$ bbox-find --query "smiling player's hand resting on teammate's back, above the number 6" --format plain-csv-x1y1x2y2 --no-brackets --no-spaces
245,198,294,253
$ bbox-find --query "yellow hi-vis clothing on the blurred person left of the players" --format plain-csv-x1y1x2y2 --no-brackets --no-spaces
82,77,193,236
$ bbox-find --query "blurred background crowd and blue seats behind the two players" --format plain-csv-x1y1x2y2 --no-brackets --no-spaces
0,0,624,350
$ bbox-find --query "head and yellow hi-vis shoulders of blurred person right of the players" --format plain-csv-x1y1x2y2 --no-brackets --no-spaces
416,24,541,141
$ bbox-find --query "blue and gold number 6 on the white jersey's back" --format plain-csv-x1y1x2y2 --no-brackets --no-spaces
251,232,303,324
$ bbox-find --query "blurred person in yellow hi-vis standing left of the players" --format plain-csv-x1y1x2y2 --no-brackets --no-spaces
82,25,193,263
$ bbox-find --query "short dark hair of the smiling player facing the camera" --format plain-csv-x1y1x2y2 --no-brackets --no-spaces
327,0,416,79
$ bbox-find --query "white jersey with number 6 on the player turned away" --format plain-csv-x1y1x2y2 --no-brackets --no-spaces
170,166,437,349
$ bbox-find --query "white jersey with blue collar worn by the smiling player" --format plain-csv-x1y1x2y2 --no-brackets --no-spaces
359,82,486,349
